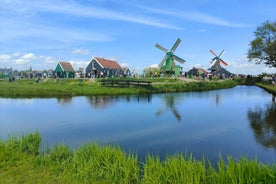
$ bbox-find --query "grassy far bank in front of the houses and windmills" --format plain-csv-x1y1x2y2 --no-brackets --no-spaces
0,79,238,98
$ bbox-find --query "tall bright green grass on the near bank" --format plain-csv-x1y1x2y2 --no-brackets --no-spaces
0,133,276,184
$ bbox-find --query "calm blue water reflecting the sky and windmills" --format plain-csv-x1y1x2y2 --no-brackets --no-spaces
0,86,276,163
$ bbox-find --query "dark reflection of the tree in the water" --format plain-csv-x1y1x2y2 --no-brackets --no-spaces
248,96,276,149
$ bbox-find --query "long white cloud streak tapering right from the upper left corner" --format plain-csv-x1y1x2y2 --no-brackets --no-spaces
3,0,181,30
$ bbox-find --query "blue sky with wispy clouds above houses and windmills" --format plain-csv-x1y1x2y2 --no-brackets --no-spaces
0,0,276,74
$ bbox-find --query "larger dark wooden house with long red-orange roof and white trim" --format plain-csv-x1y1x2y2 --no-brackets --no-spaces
85,57,124,78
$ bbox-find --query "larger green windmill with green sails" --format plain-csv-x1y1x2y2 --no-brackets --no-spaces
155,38,185,77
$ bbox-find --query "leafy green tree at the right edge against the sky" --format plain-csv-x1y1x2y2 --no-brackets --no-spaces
247,21,276,67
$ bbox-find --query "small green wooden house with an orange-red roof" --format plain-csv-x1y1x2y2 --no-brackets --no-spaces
55,62,75,78
